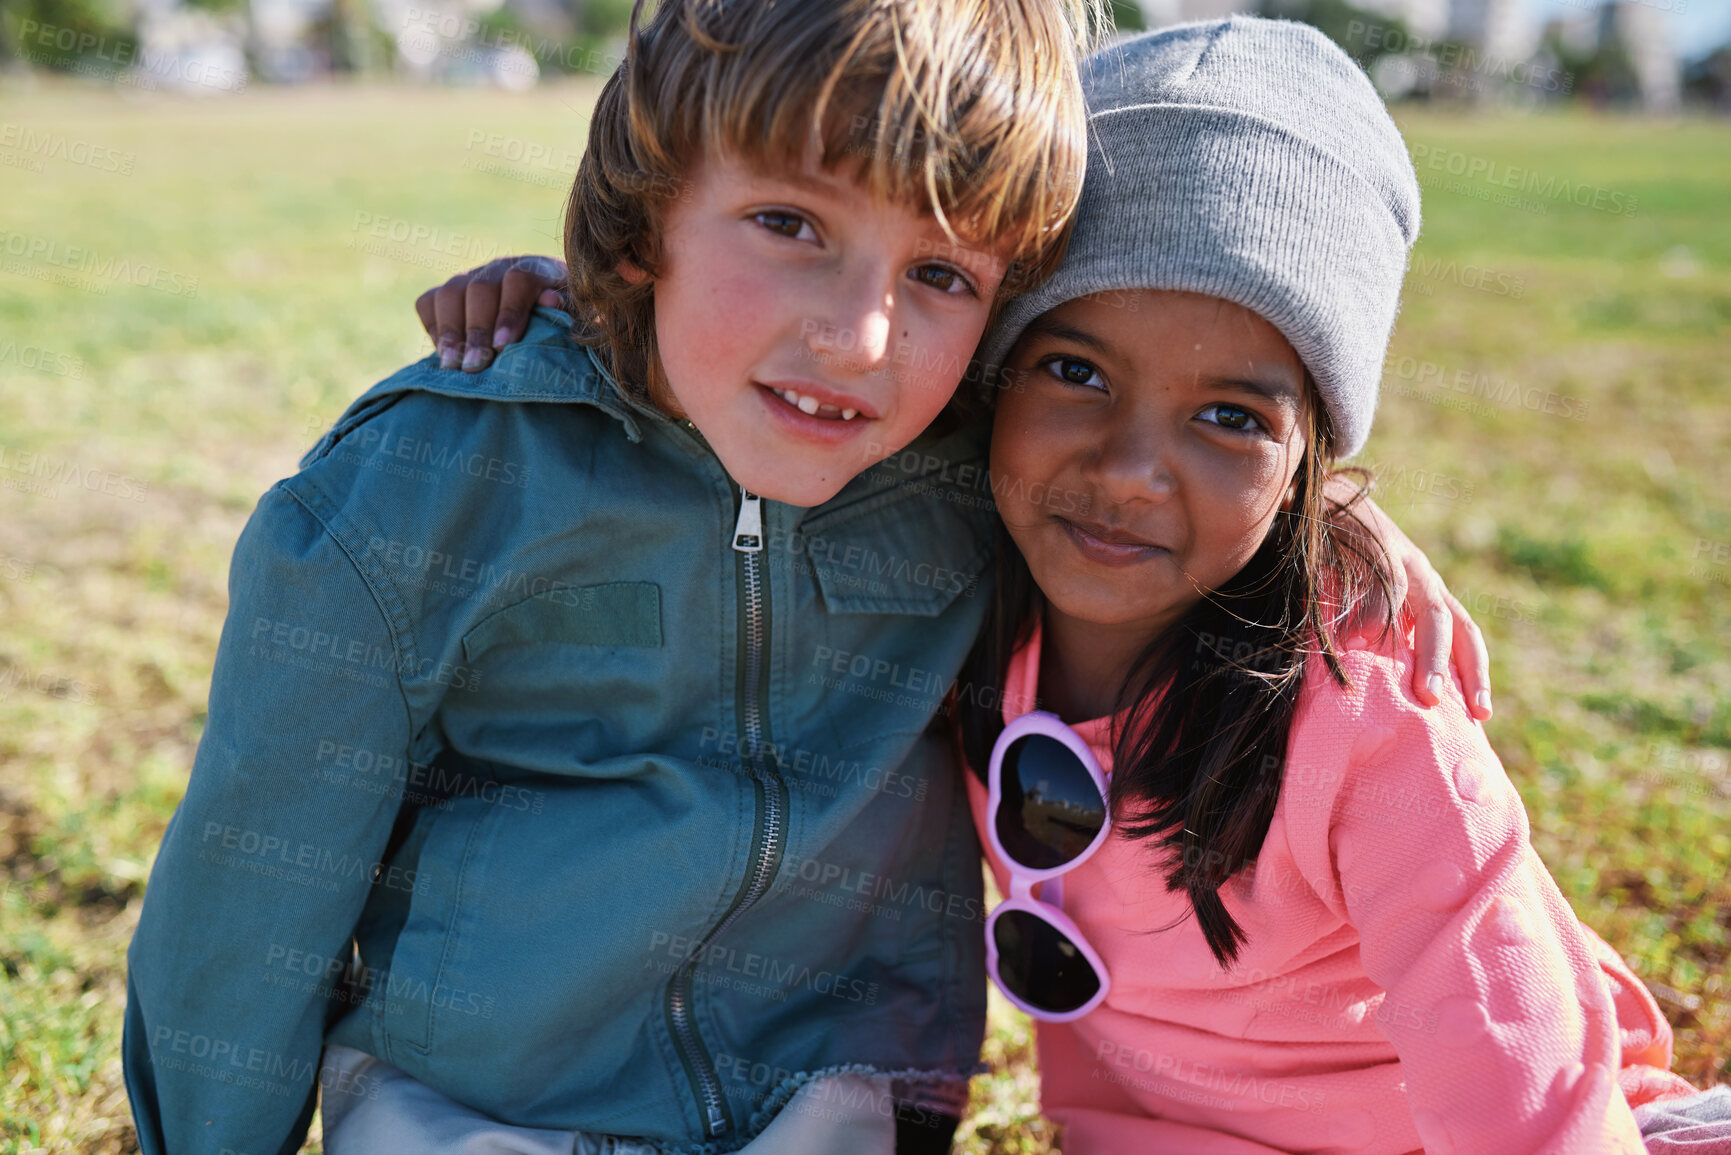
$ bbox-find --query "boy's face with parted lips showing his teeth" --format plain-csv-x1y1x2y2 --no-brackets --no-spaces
654,148,1006,506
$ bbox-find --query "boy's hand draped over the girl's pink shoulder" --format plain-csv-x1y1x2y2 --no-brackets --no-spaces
1354,497,1490,722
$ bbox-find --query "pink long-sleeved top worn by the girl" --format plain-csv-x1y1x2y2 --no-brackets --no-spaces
968,630,1693,1155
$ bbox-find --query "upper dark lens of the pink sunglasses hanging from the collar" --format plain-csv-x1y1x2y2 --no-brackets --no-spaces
995,734,1106,871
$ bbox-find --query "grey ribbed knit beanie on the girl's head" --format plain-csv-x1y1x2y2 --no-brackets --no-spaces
981,16,1419,457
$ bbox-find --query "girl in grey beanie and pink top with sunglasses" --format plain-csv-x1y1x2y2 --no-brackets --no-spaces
961,17,1693,1155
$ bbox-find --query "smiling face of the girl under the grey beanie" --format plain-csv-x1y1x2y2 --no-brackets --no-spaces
992,291,1307,644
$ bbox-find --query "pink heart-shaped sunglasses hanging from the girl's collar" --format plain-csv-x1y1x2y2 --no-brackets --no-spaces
985,710,1111,1023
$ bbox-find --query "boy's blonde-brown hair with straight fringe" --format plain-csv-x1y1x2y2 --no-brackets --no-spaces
564,0,1108,397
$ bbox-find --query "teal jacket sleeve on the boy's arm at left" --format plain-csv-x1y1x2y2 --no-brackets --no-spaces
123,485,414,1155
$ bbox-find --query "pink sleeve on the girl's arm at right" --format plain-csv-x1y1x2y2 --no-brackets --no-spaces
1288,651,1644,1155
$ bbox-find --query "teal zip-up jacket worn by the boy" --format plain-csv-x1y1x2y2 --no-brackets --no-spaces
125,310,994,1155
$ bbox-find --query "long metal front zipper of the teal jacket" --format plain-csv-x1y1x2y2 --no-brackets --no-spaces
666,490,788,1139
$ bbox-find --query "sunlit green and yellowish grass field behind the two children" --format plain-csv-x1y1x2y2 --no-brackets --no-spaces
0,76,1731,1155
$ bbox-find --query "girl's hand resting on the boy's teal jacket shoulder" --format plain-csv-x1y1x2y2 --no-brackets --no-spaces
415,256,566,372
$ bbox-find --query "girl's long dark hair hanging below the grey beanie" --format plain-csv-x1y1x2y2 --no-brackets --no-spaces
961,406,1393,966
